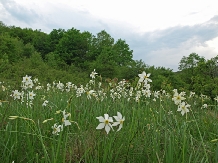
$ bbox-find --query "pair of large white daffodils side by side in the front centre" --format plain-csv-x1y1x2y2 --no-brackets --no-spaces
96,112,125,134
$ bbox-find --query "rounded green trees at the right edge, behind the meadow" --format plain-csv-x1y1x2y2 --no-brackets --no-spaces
179,53,218,99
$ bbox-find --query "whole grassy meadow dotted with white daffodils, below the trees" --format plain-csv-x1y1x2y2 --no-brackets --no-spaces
0,70,218,163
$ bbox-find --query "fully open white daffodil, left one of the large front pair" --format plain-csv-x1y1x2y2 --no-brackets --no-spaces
96,114,113,134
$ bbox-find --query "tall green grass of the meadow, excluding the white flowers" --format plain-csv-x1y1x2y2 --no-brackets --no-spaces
0,74,218,163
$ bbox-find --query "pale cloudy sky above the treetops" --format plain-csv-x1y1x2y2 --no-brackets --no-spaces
0,0,218,71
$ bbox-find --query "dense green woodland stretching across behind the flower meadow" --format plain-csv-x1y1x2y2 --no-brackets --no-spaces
0,22,218,99
